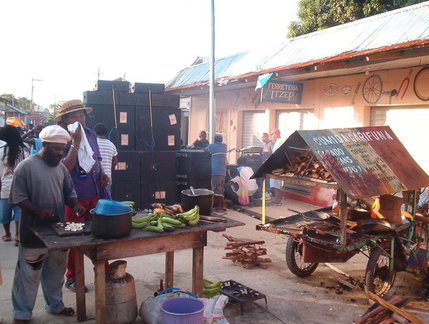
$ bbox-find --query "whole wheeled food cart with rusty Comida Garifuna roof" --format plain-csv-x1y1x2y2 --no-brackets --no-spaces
253,126,429,295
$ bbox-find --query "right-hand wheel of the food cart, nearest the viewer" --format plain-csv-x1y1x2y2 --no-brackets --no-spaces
365,242,396,295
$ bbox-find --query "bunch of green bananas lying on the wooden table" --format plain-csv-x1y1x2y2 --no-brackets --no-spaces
131,206,200,233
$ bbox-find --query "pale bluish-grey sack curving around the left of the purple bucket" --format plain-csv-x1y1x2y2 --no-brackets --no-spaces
139,288,198,324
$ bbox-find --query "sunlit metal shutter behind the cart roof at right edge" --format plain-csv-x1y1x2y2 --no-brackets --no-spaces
371,106,429,173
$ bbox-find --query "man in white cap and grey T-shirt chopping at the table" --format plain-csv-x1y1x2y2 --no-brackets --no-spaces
9,126,85,324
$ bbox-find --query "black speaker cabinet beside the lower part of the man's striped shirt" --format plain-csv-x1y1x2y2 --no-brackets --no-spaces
112,151,141,182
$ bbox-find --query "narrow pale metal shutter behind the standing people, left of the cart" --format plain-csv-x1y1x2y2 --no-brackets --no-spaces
241,111,269,148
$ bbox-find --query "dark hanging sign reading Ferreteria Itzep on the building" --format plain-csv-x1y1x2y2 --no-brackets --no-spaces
261,81,303,104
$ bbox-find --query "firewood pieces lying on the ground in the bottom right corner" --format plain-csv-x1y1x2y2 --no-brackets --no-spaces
357,292,424,324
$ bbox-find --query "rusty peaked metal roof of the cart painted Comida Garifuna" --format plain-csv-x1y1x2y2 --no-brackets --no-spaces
253,126,429,199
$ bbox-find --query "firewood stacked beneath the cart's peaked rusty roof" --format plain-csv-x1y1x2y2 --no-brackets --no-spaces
273,151,334,181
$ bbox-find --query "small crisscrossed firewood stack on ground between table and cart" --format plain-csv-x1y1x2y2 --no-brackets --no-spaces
222,234,271,269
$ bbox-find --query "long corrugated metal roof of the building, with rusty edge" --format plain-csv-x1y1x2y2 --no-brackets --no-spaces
166,1,429,89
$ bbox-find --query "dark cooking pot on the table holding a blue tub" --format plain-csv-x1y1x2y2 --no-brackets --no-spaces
91,208,133,239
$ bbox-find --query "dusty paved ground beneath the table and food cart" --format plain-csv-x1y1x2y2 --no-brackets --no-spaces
0,200,429,324
